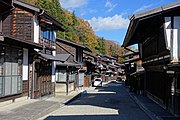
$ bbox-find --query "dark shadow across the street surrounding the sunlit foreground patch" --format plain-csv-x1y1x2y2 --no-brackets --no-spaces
43,82,148,120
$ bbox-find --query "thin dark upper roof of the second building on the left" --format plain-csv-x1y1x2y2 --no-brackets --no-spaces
56,38,92,52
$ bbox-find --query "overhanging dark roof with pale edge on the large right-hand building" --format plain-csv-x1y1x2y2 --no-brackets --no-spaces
122,1,180,47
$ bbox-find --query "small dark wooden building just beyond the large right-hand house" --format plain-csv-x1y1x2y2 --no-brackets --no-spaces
123,50,144,94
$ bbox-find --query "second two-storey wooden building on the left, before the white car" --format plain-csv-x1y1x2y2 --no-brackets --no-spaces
56,38,91,94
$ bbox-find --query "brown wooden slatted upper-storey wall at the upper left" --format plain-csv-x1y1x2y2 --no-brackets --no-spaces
3,8,34,43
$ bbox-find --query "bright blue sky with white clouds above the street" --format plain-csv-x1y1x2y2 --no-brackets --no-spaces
59,0,177,45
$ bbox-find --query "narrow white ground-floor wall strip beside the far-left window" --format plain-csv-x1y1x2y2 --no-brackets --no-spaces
22,48,29,80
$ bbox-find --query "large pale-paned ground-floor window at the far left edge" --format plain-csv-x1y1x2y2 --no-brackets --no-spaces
0,45,23,97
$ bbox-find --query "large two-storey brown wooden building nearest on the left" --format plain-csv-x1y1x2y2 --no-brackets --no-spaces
0,0,62,101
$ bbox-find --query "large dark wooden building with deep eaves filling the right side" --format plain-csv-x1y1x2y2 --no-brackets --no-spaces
123,2,180,116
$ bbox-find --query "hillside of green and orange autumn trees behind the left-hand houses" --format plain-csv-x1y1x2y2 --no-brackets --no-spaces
23,0,124,62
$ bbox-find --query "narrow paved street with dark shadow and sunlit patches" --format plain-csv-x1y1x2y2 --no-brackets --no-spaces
41,83,149,120
